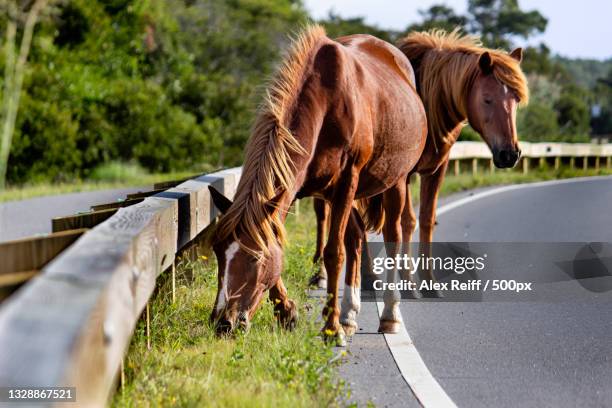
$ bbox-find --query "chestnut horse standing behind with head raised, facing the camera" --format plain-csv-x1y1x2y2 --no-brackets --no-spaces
311,30,528,315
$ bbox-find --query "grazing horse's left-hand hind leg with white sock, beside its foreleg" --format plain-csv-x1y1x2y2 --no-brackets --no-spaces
340,208,365,336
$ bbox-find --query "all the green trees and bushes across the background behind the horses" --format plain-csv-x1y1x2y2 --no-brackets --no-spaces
0,0,612,183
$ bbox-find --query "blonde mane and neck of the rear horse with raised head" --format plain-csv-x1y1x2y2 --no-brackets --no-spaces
398,29,529,146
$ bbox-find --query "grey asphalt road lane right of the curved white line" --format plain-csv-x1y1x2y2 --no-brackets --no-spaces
401,177,612,407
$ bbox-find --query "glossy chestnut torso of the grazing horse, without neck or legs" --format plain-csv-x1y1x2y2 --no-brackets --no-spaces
301,35,427,197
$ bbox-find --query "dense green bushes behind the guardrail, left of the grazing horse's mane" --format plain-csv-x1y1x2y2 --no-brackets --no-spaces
5,0,306,184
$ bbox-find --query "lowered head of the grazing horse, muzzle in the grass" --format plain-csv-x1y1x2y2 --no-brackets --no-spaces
209,187,283,334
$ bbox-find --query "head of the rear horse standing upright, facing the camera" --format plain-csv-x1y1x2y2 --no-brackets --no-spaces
467,48,523,168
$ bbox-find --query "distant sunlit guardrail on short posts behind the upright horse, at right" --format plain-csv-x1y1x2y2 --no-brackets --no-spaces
449,142,612,175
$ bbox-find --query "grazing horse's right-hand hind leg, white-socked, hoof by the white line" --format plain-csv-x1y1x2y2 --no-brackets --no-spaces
378,179,406,333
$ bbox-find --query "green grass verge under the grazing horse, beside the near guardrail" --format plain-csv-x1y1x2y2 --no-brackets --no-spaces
113,199,346,407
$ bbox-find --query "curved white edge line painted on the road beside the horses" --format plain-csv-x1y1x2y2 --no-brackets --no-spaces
376,176,603,408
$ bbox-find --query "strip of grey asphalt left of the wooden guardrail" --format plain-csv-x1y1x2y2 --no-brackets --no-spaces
0,187,145,242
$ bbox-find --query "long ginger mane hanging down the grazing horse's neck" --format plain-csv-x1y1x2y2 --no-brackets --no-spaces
216,25,326,256
